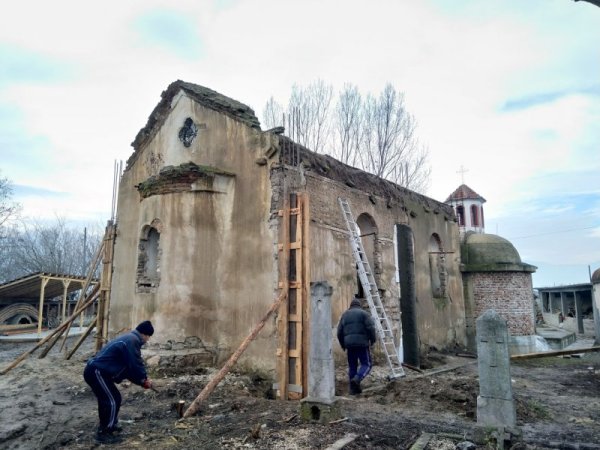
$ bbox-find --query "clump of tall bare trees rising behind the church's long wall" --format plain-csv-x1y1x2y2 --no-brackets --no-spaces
264,80,431,192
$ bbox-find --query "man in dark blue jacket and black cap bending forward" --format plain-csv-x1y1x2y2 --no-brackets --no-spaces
83,320,154,443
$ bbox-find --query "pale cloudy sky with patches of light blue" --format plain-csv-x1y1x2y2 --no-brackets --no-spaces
0,0,600,287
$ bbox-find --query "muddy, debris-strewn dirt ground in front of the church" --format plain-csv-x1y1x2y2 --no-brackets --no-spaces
0,338,600,450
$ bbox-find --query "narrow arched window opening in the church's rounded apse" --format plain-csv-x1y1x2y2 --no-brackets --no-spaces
137,221,161,292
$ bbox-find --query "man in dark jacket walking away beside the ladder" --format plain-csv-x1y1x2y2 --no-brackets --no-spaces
337,297,377,395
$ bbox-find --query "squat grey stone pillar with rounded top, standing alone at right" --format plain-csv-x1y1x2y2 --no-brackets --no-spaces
477,309,517,428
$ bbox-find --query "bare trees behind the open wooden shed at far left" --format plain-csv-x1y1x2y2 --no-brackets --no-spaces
0,217,102,282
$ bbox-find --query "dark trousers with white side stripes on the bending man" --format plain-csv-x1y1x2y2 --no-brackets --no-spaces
83,363,121,431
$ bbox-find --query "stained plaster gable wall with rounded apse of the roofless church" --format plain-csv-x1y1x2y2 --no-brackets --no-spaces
111,92,277,365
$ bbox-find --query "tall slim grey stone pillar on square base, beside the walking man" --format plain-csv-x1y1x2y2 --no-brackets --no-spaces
300,281,340,423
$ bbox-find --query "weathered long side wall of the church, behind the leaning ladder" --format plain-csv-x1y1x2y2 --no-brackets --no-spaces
274,165,466,350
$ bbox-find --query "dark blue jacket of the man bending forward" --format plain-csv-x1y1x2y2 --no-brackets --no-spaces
88,330,148,386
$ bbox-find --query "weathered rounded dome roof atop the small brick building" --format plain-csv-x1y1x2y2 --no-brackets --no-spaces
461,233,536,272
